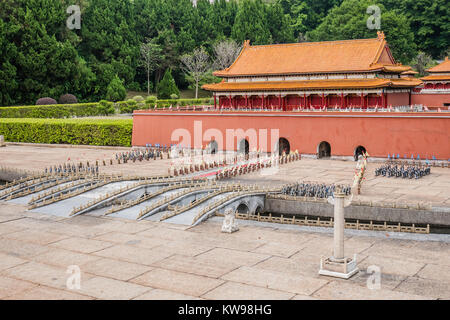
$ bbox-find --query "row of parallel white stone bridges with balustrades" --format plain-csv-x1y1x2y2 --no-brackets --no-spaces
0,175,280,225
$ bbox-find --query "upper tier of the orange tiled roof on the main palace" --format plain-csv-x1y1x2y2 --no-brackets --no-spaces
214,32,411,77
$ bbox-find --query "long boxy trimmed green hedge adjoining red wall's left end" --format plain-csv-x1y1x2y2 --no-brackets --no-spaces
0,119,133,146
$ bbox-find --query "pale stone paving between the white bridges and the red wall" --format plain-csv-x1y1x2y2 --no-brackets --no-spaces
0,145,450,207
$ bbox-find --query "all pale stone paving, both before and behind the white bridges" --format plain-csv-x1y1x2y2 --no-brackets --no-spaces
0,145,450,300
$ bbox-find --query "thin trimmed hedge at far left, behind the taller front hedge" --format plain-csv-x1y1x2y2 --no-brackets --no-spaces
0,103,101,119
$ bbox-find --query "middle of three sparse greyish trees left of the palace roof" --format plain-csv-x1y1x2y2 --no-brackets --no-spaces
181,48,211,99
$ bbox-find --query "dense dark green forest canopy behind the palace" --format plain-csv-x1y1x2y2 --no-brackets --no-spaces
0,0,450,106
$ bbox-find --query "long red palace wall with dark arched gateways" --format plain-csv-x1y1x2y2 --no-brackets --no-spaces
132,110,450,159
